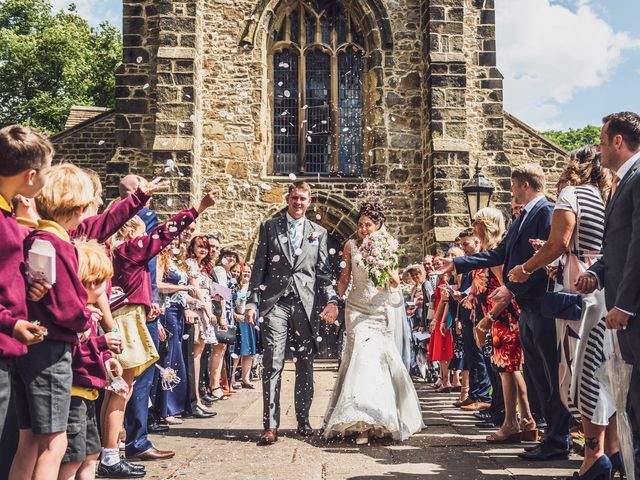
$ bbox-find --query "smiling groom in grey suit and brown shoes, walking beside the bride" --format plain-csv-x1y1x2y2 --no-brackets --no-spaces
246,181,338,445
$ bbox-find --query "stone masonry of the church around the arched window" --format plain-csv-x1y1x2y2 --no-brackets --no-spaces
56,0,564,259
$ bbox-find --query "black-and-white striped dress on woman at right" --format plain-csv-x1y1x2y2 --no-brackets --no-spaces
556,185,615,425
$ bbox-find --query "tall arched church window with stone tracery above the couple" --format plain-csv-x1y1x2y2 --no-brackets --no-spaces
270,0,365,176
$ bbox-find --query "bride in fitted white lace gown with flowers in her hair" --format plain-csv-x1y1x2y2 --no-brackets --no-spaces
324,203,424,445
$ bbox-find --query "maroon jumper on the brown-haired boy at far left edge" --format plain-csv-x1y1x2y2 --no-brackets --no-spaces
0,195,27,363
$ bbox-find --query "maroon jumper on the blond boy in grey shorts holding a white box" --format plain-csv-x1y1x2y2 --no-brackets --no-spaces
24,220,92,345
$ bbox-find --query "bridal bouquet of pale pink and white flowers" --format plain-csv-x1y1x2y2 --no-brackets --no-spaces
359,230,400,288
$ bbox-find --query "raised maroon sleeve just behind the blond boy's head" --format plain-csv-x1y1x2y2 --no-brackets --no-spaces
69,189,151,243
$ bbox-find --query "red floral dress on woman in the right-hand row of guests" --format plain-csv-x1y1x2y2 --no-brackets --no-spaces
471,269,523,373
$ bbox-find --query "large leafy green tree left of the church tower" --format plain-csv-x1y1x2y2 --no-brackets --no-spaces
0,0,122,133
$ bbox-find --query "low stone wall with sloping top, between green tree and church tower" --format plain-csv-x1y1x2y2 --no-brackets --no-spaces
51,111,116,188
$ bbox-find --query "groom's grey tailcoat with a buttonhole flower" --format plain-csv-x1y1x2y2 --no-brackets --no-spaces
248,215,338,325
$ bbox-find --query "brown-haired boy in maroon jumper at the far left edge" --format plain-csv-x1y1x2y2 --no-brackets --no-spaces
0,125,53,437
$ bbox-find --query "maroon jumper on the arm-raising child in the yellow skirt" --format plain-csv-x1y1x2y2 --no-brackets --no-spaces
111,208,198,313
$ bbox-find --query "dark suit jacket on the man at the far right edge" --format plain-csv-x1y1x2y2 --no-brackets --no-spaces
589,156,640,315
